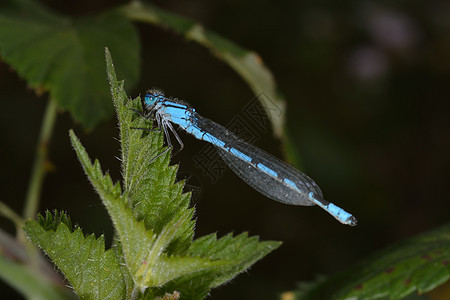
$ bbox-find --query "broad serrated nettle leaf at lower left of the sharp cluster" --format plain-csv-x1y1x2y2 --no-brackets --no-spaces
24,212,125,299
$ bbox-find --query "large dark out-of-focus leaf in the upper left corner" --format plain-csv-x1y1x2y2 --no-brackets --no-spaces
0,0,139,129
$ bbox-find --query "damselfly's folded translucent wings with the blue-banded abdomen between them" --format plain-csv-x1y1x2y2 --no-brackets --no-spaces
191,117,322,206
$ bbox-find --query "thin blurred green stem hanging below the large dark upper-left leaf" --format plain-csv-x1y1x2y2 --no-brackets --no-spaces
23,99,56,219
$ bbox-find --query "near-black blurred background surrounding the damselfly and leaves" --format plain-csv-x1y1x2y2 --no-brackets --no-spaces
0,0,450,299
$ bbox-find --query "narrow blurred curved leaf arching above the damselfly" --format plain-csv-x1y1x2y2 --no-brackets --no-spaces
122,1,286,137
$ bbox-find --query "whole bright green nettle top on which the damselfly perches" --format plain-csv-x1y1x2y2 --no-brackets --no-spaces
26,50,279,299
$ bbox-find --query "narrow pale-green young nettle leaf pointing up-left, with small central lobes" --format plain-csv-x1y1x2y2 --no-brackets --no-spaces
70,119,202,291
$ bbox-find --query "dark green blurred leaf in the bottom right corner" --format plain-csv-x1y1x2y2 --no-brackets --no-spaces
296,224,450,299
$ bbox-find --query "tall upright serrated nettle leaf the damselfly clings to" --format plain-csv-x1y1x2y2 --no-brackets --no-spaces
106,51,195,255
